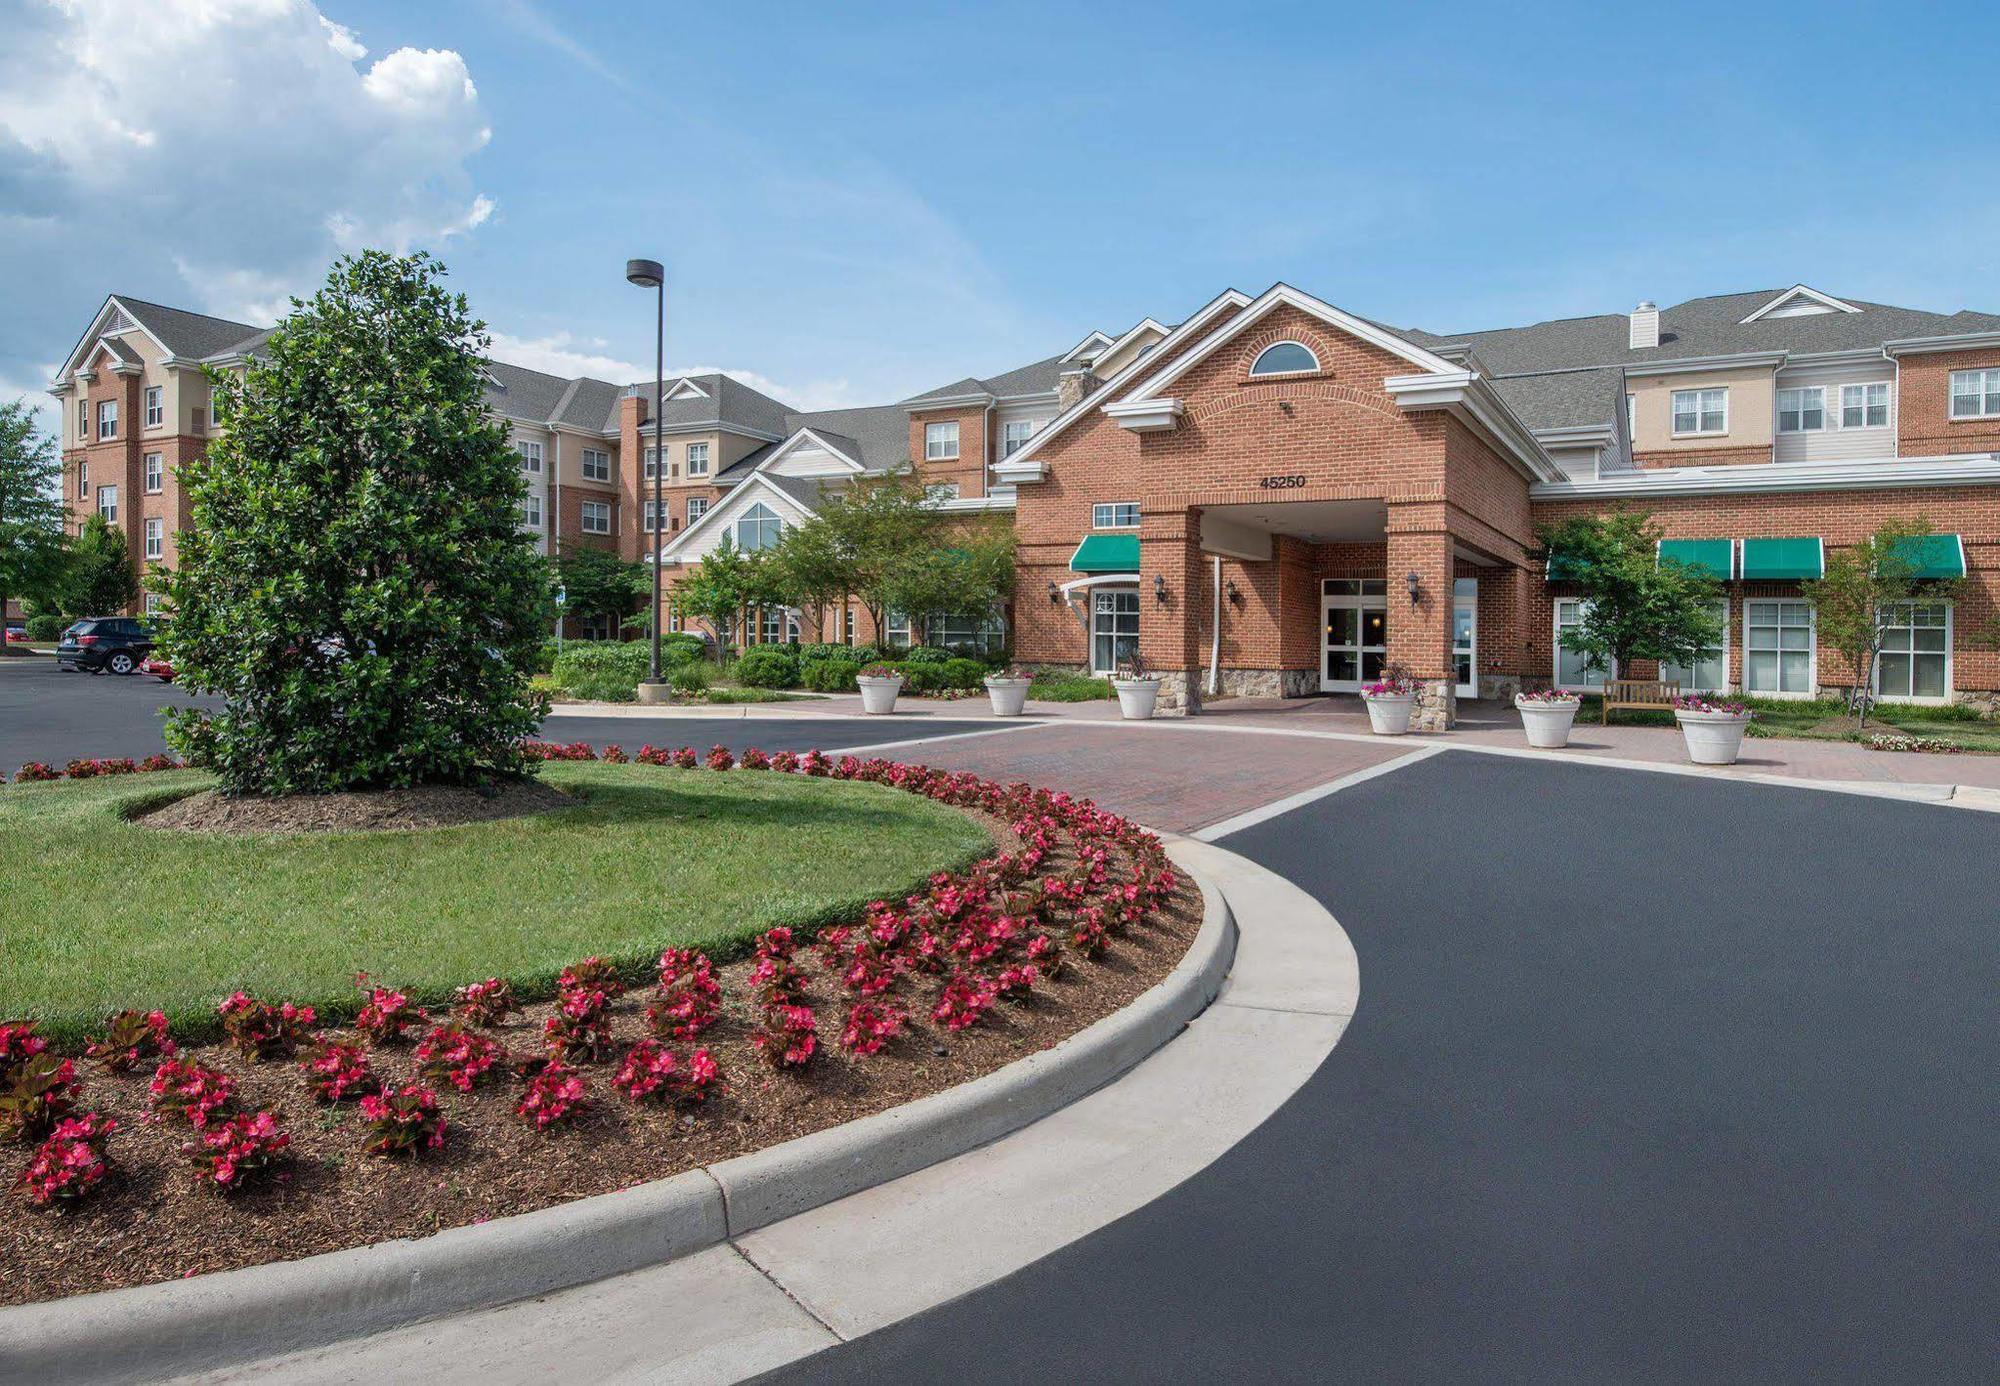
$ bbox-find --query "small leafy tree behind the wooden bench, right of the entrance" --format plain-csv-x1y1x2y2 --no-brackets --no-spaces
1536,510,1722,670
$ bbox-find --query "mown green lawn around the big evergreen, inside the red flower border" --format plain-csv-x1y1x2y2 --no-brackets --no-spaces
0,762,990,1042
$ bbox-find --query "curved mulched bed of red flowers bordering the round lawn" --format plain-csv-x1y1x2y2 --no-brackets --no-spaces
0,744,1200,1302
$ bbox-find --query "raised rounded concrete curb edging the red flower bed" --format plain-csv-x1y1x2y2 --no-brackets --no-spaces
0,844,1236,1384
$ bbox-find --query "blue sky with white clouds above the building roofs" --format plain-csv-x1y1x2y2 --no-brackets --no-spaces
0,0,2000,418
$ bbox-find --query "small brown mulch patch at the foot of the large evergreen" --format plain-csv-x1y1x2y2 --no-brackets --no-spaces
132,780,576,832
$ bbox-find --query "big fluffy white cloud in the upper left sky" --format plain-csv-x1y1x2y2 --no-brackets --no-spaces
0,0,494,320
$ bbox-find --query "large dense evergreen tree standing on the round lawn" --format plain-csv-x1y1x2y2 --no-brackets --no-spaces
164,250,548,794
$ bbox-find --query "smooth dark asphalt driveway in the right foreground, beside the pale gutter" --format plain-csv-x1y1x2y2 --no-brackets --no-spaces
764,754,2000,1382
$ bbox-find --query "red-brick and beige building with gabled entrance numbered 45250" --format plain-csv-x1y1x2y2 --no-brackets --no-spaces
52,284,2000,726
